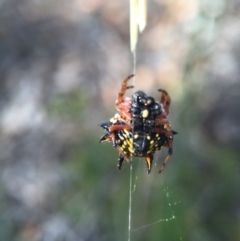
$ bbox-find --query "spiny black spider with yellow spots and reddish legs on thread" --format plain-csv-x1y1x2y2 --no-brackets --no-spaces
99,75,177,173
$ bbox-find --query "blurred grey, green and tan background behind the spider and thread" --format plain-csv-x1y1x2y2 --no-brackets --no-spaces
0,0,240,241
